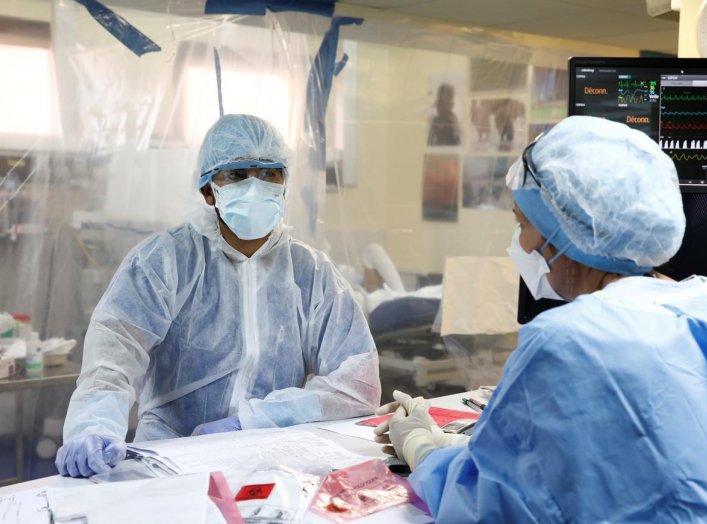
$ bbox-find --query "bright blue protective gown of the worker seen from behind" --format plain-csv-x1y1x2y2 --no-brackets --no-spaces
410,277,707,523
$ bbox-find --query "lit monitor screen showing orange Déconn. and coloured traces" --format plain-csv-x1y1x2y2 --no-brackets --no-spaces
569,58,707,191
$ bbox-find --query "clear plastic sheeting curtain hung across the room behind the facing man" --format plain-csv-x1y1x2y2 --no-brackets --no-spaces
0,0,620,484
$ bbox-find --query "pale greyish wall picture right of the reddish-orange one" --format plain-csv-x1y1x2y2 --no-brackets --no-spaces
462,155,517,209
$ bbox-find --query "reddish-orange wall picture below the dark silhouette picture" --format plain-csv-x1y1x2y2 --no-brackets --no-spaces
422,154,460,222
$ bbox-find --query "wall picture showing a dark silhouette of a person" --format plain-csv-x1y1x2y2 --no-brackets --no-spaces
427,76,464,147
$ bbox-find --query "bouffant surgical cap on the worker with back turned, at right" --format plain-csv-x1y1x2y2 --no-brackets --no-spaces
507,116,685,275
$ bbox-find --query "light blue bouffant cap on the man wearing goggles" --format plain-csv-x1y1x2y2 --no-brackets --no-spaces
199,115,289,189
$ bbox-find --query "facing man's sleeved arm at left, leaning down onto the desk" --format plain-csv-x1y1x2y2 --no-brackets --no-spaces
57,241,175,466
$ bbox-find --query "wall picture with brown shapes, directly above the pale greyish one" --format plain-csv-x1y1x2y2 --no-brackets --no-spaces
469,97,526,153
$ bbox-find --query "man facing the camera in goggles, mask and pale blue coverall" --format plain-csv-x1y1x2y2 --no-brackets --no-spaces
56,115,380,476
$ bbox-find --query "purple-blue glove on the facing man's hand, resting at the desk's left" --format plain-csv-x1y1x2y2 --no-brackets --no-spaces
54,435,128,477
